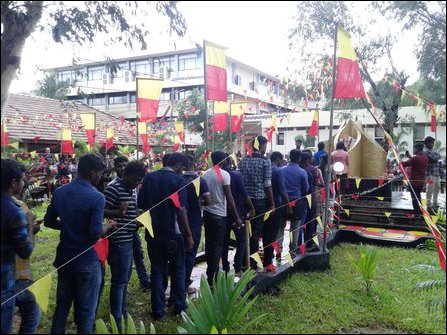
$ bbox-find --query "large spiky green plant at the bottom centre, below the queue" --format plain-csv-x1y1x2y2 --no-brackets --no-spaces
178,270,263,334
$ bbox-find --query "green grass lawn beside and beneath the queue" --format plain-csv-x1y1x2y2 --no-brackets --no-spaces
27,208,446,334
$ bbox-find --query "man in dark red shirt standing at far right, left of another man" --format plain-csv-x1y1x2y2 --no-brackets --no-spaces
402,143,428,214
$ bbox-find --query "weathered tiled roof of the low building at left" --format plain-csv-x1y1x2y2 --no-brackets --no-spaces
2,94,141,145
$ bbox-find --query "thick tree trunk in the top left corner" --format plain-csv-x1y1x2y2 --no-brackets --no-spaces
1,1,43,113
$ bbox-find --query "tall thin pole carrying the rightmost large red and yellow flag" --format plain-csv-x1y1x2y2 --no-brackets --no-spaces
318,24,338,252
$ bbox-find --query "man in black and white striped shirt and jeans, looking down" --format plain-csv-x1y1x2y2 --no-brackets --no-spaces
104,161,146,332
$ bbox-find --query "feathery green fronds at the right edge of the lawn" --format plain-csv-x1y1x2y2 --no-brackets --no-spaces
413,264,446,315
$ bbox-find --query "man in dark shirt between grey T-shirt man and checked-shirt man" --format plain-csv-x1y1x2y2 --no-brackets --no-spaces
222,157,255,277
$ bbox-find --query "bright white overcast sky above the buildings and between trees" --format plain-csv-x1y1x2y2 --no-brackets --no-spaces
10,1,418,93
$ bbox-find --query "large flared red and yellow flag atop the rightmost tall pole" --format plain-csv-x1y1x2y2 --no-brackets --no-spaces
334,28,365,99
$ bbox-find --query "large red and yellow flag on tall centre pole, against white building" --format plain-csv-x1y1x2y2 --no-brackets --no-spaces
205,42,227,101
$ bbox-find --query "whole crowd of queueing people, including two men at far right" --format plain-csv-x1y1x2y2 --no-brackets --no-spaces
1,136,446,334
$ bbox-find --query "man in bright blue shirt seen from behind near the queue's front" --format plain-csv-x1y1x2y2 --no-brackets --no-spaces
282,149,309,254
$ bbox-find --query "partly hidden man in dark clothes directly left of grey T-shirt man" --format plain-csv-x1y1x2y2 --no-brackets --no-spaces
183,156,211,294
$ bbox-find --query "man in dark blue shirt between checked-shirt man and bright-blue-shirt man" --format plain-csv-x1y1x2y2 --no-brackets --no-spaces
262,151,291,272
